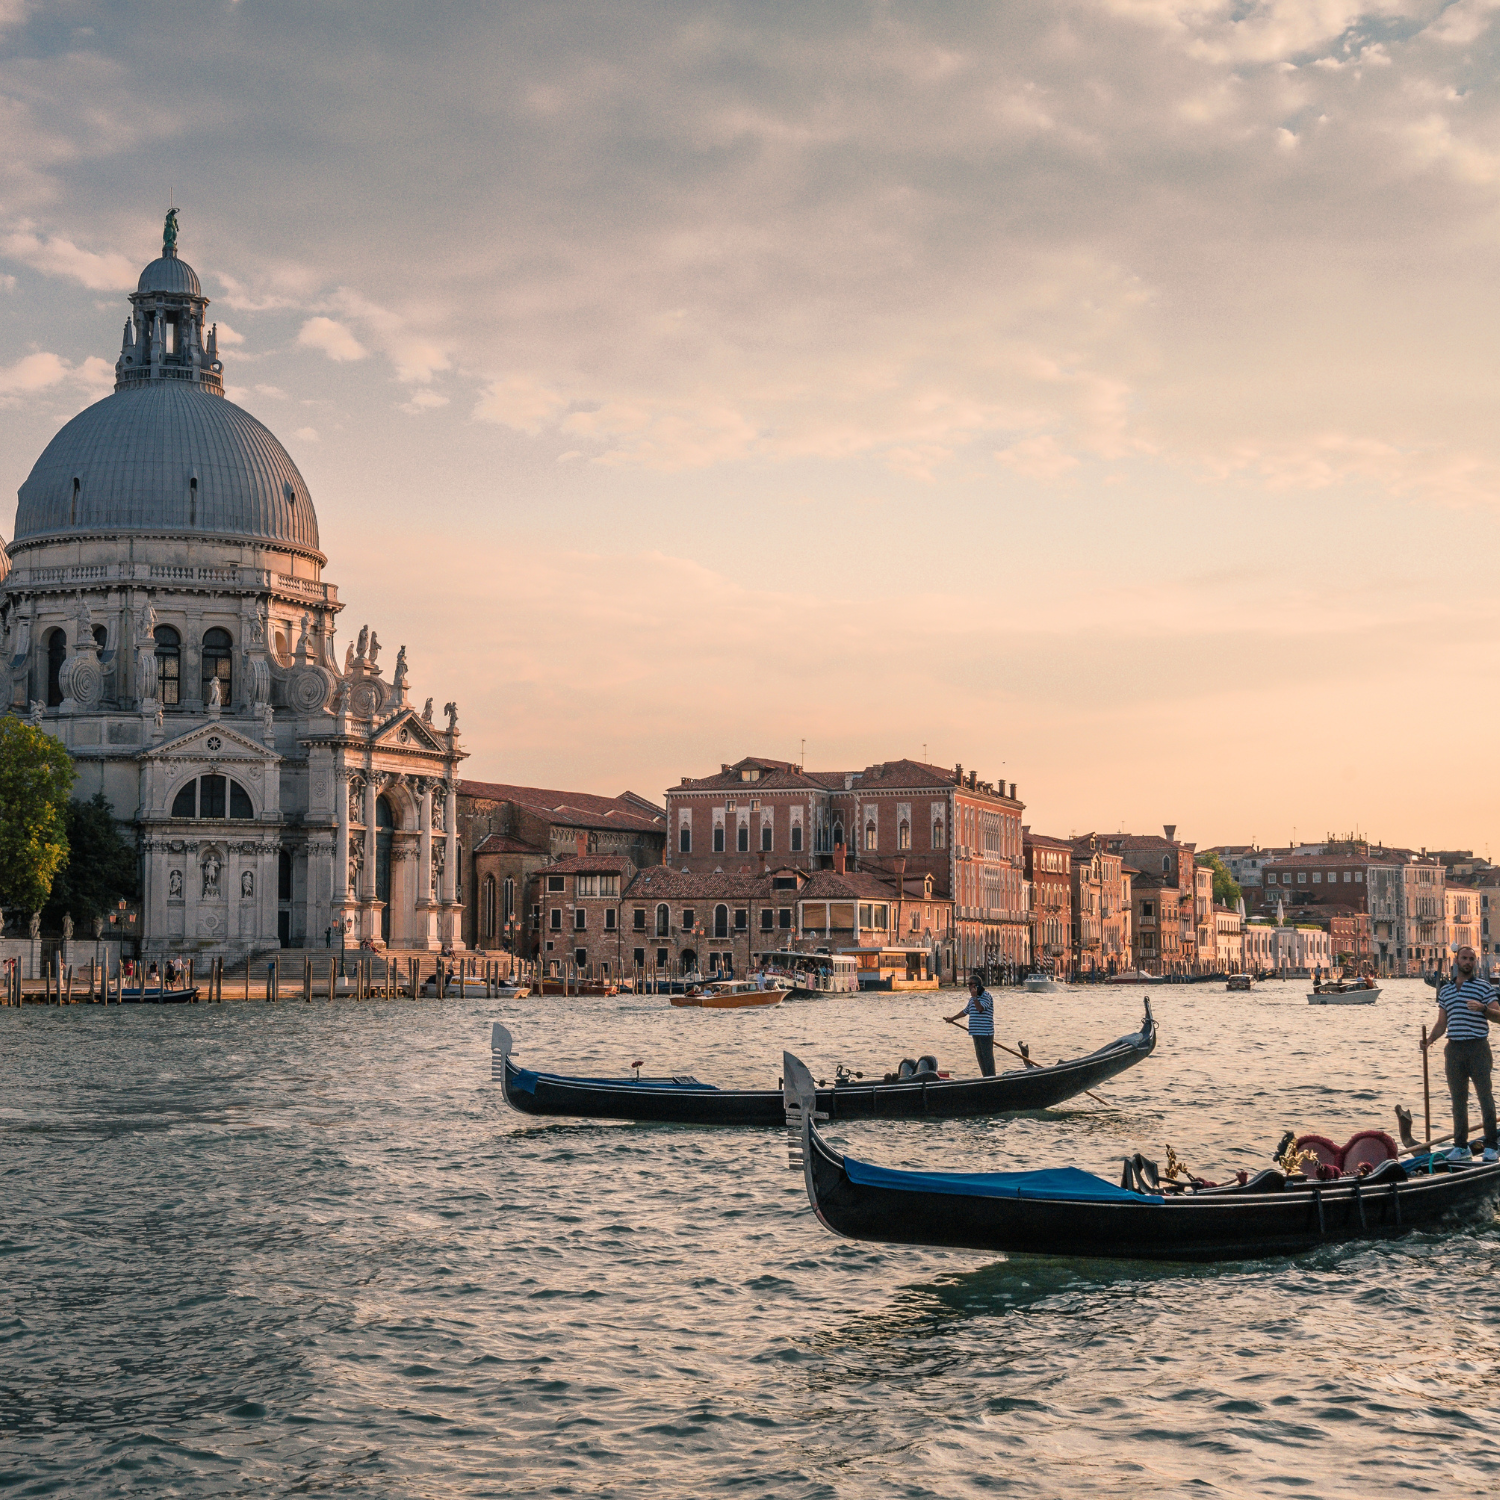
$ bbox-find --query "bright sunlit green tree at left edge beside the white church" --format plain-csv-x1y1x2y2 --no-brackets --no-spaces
0,714,74,912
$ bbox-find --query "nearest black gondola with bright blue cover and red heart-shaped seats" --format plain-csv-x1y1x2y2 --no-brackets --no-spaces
783,1055,1500,1260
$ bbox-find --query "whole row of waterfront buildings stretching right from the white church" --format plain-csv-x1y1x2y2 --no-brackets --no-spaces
458,756,1476,987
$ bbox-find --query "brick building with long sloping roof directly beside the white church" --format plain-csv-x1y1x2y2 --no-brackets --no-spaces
458,782,666,959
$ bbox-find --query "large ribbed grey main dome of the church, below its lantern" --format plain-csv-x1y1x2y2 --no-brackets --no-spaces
15,381,318,552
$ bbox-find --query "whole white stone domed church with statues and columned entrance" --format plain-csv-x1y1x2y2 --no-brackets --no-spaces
0,210,464,960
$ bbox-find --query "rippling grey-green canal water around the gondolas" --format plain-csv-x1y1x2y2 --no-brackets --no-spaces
0,981,1500,1500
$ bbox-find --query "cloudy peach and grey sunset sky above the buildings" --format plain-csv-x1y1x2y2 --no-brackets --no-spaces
0,0,1500,858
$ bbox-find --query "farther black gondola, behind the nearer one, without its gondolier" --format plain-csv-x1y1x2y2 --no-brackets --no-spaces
491,1001,1157,1125
